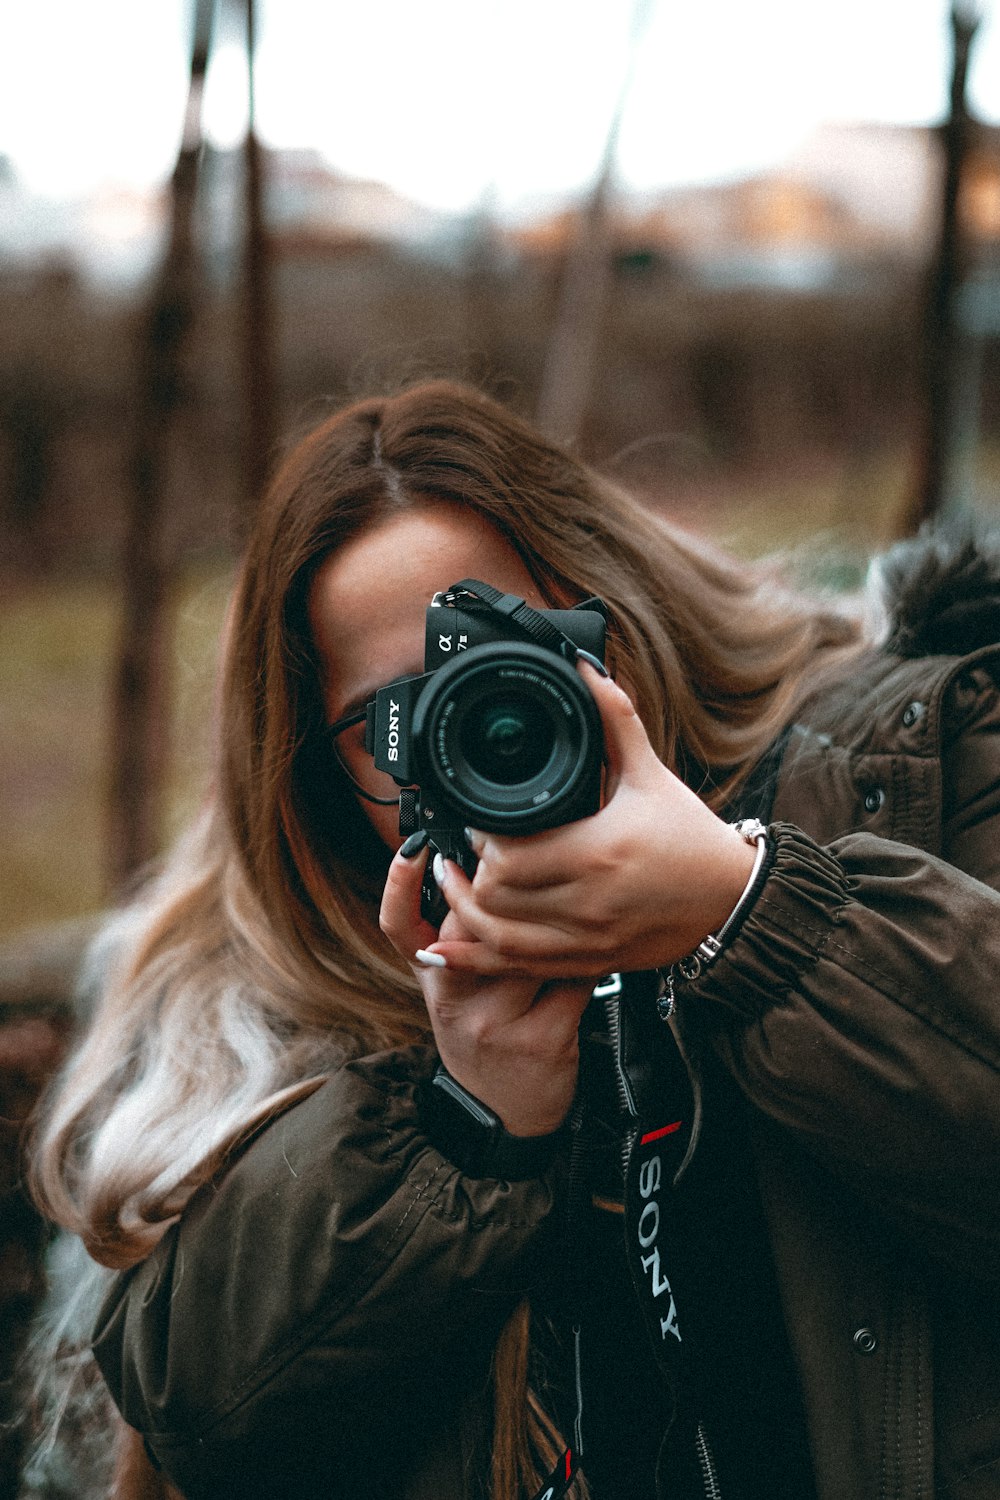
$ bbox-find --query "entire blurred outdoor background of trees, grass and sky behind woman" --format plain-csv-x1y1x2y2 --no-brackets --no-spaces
0,0,1000,1500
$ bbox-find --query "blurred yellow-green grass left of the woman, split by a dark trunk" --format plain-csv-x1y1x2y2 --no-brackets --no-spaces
0,563,231,936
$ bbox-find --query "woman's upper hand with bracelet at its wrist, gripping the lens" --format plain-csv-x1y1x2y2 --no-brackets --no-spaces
419,666,754,980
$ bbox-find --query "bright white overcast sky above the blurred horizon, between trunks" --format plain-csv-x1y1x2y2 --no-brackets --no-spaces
0,0,1000,209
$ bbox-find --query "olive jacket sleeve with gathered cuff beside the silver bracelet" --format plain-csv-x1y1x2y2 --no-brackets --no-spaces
687,666,1000,1281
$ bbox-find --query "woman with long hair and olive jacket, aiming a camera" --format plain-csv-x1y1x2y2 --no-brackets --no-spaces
27,383,1000,1500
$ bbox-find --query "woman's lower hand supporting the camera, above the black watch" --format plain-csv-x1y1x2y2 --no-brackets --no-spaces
379,854,592,1136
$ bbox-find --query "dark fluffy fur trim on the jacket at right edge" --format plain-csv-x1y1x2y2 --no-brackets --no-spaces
871,521,1000,657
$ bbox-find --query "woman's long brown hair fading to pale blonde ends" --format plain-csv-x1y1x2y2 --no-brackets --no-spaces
33,383,859,1497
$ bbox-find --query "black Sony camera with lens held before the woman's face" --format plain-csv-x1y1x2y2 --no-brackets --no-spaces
364,579,606,923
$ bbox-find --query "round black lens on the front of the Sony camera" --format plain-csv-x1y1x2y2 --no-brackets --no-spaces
412,641,603,834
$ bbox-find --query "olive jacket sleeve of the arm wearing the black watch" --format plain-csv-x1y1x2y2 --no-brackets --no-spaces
94,1049,563,1500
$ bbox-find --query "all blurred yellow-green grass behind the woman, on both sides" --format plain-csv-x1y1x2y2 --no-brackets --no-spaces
0,438,996,938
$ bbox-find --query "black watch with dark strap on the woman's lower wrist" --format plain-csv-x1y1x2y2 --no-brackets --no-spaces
423,1062,564,1182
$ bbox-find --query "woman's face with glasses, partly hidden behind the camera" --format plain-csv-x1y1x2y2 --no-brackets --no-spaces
309,501,546,849
